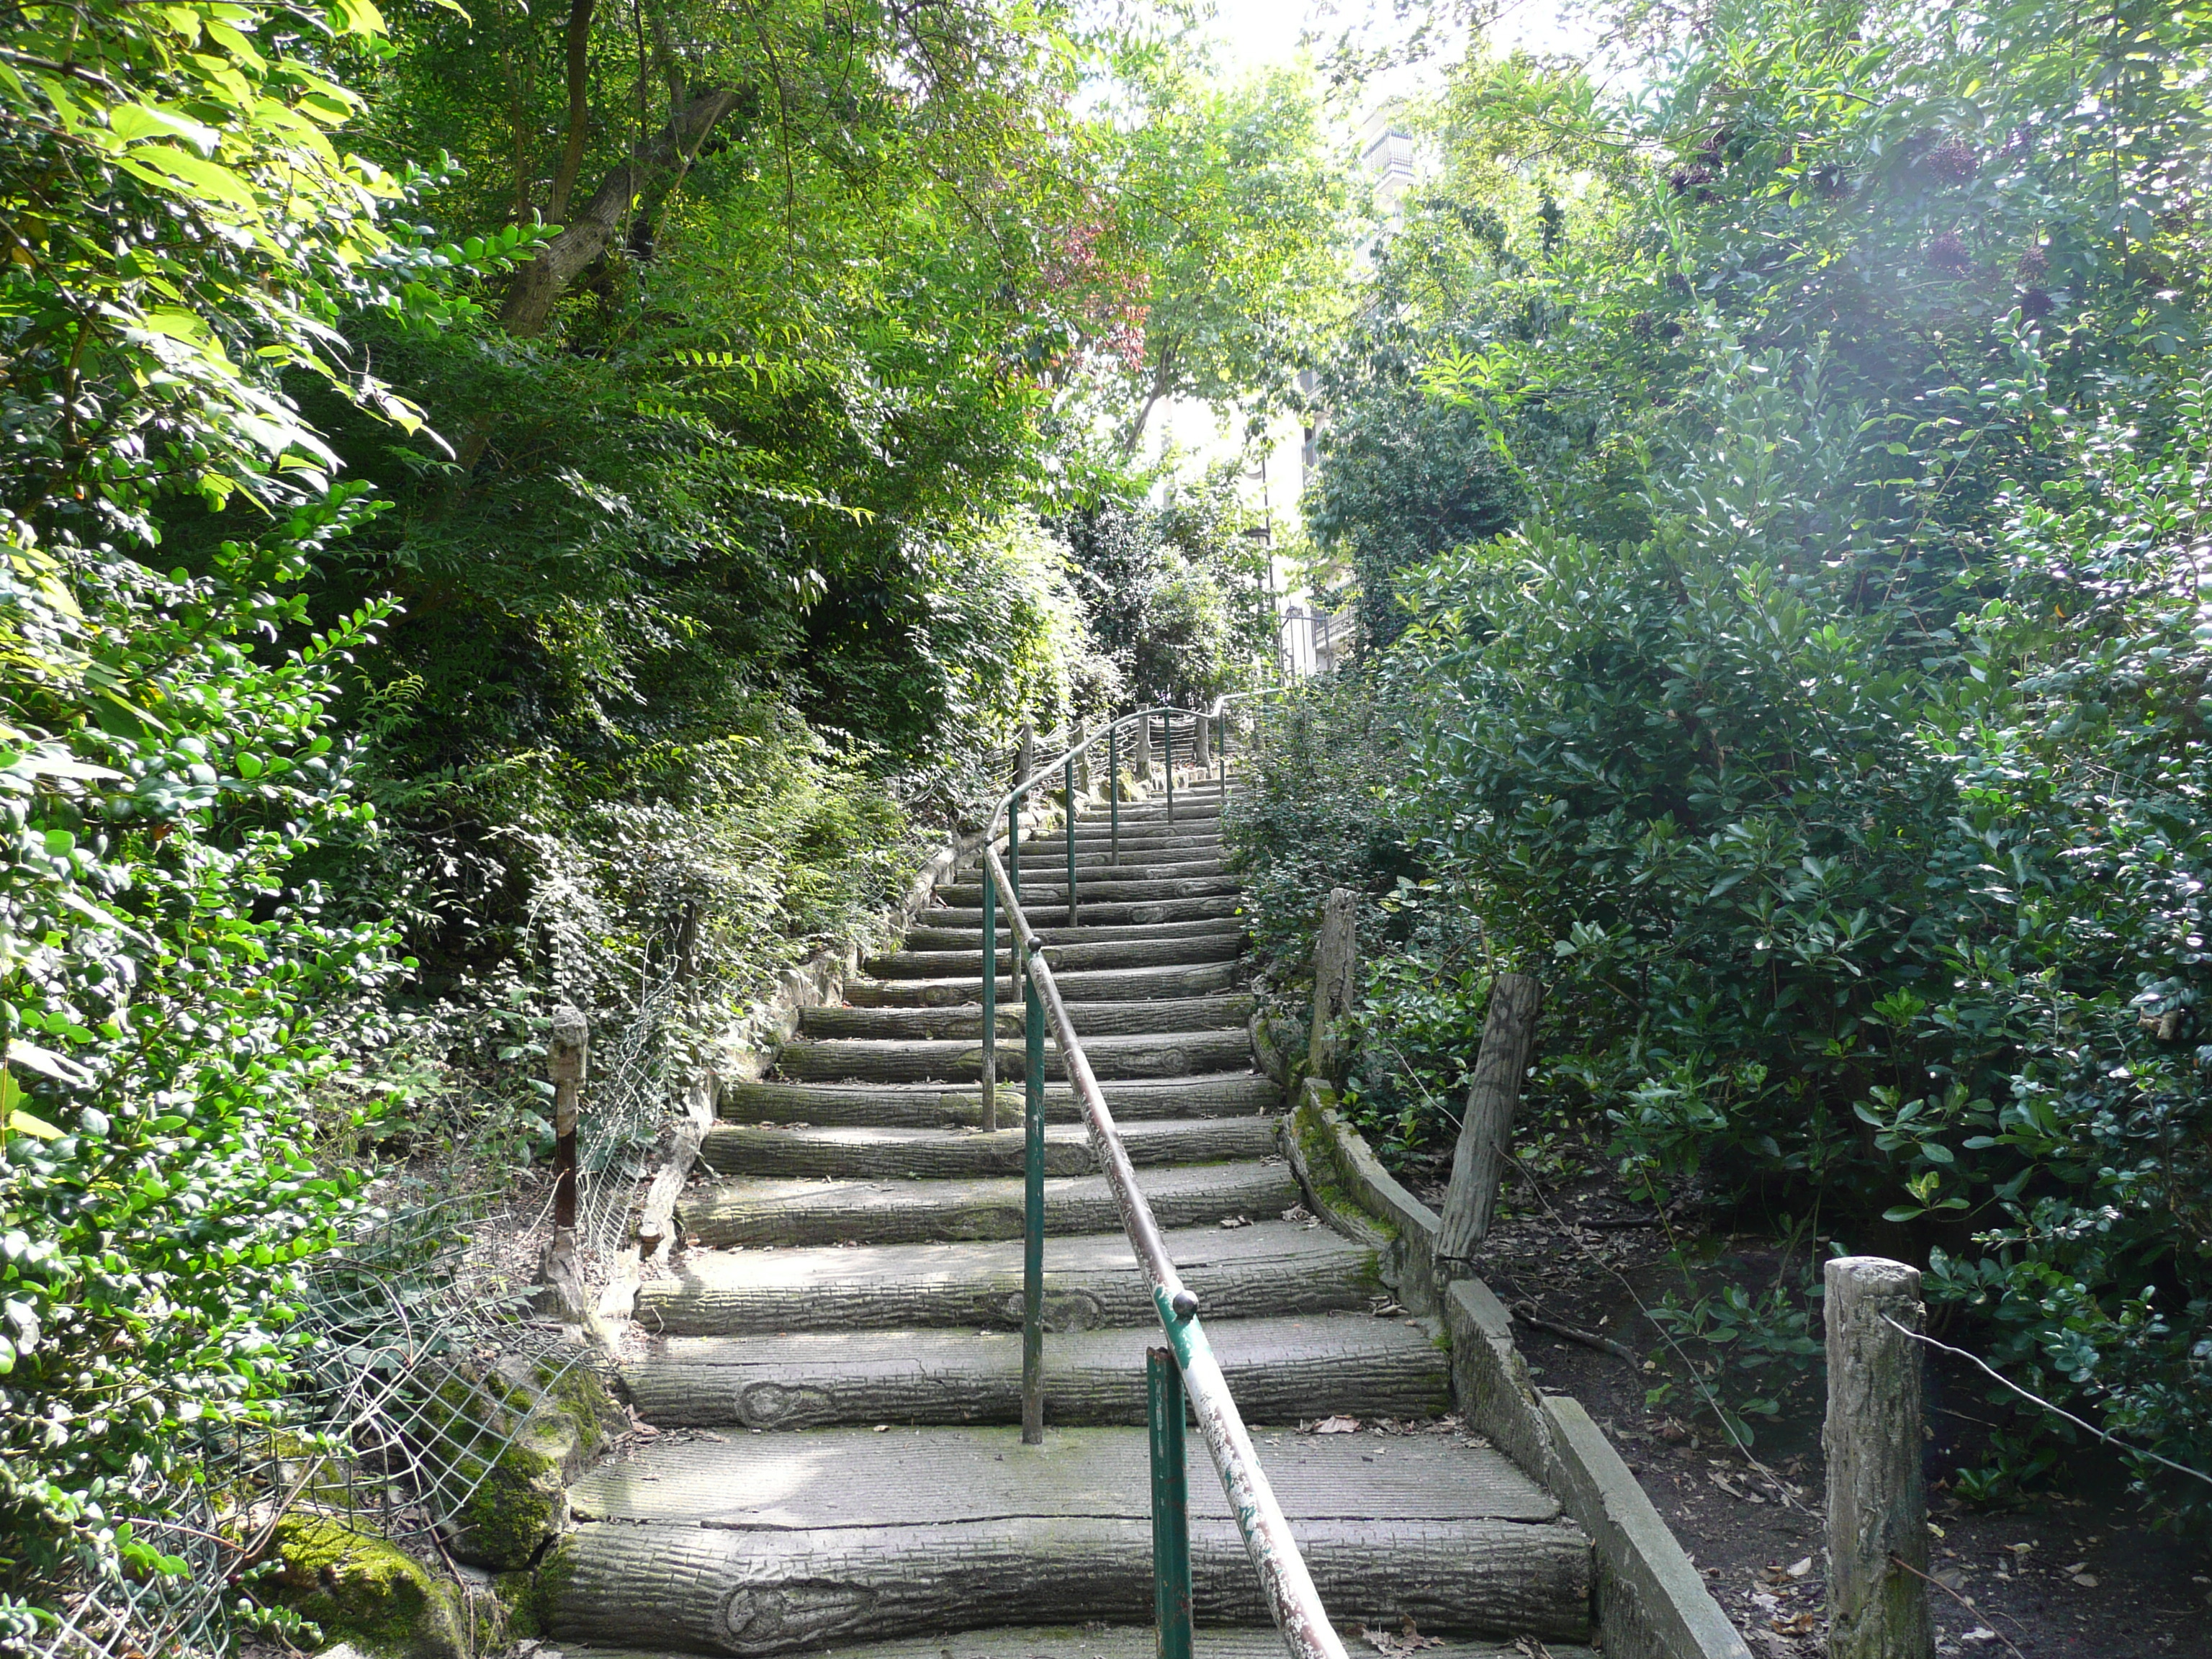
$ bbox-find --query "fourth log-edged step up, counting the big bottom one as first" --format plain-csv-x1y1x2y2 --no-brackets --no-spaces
679,1159,1300,1246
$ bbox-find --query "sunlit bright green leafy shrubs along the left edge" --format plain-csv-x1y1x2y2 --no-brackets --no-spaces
0,4,471,1635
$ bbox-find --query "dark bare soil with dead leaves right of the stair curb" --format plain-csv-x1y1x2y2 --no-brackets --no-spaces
1409,1170,2212,1659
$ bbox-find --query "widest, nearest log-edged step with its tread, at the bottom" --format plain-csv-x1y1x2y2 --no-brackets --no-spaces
547,1429,1591,1655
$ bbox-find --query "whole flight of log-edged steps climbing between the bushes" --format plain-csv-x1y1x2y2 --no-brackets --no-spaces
549,786,1591,1659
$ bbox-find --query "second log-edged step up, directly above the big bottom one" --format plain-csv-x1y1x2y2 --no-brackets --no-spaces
626,1312,1451,1429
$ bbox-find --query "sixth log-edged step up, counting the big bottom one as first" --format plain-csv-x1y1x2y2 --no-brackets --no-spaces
721,1073,1283,1128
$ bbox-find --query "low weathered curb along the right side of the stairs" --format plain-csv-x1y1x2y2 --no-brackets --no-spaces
1283,1079,1752,1659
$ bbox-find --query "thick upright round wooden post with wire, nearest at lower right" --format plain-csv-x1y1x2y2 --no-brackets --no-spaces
1820,1256,1936,1659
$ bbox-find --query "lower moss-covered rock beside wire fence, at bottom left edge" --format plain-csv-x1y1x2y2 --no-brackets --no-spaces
272,1513,473,1659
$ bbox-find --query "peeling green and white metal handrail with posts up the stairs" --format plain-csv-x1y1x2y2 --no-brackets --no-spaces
960,688,1345,1659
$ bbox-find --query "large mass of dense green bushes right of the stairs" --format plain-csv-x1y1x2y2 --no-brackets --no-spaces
1254,4,2212,1519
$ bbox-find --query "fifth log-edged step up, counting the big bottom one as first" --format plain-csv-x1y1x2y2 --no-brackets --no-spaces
699,1119,1279,1181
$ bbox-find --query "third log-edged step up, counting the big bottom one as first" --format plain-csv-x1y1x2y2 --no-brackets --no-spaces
637,1221,1382,1336
